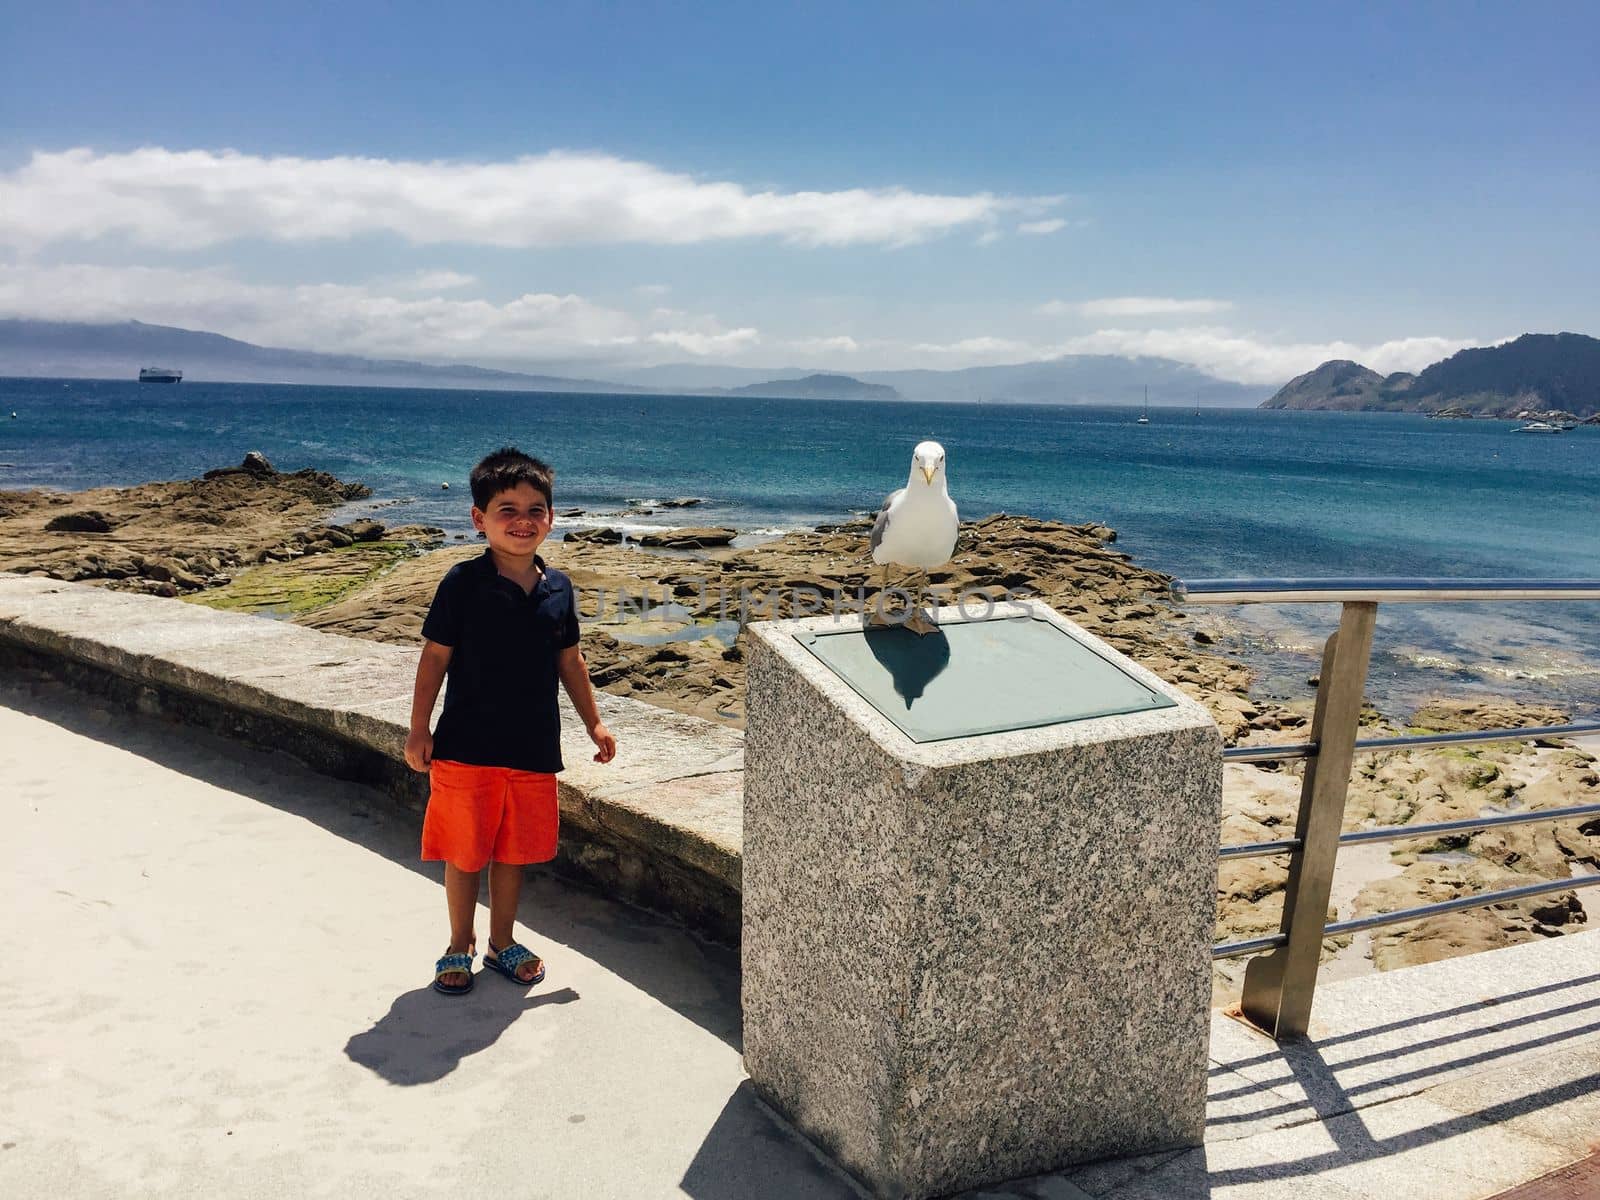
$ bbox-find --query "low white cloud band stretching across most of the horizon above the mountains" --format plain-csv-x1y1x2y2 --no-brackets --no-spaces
0,262,1478,384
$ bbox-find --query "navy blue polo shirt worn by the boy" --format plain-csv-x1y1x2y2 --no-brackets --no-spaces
422,550,578,773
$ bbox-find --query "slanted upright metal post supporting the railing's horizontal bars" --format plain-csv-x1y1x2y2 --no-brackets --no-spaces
1242,602,1378,1040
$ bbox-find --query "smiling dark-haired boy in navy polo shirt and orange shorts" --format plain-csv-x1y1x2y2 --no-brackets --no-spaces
405,446,616,995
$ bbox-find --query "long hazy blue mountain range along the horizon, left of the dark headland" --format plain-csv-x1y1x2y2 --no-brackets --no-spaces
0,320,1270,408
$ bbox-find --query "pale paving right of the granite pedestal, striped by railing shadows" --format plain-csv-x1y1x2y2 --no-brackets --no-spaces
1036,933,1600,1200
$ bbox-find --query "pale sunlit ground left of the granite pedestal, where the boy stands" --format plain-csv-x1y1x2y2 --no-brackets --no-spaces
0,683,851,1200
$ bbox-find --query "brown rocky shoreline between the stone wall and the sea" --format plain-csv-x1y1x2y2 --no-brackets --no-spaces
0,456,1600,1003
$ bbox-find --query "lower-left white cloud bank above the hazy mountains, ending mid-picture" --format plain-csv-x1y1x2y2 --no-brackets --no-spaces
0,264,758,360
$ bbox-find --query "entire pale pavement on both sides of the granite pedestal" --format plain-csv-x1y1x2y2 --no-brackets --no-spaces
9,680,1600,1200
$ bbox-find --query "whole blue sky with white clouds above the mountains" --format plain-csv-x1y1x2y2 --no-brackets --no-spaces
0,2,1600,382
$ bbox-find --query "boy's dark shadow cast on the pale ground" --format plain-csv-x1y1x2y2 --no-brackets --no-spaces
344,979,579,1086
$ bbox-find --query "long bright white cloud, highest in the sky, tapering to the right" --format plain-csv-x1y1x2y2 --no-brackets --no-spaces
0,147,1061,250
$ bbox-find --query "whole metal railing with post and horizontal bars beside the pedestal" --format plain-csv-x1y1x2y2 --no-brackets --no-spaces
1173,579,1600,1040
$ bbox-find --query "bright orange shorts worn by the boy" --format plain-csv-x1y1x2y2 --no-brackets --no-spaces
422,758,560,870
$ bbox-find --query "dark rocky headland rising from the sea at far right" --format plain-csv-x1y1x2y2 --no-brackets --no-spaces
1261,333,1600,418
